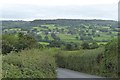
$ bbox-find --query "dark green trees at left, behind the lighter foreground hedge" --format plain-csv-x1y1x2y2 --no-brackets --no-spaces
2,33,37,54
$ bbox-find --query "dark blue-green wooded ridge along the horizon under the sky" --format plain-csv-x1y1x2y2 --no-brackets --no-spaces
2,19,118,28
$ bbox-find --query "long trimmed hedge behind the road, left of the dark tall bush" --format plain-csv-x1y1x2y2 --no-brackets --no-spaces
56,48,104,75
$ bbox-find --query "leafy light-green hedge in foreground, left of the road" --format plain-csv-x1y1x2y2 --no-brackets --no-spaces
2,49,56,78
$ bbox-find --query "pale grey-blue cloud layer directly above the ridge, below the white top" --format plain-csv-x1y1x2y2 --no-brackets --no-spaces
1,4,118,20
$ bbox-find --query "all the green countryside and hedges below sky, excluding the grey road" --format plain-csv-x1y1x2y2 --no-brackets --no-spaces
2,19,120,78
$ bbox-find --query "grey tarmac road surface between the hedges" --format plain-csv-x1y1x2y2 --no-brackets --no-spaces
57,68,103,78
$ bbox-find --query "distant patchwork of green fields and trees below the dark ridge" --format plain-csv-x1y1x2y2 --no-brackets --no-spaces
3,20,119,44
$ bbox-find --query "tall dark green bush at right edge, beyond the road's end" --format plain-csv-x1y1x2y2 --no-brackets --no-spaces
101,39,119,77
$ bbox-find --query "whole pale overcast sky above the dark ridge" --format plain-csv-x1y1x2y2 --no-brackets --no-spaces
0,0,119,21
